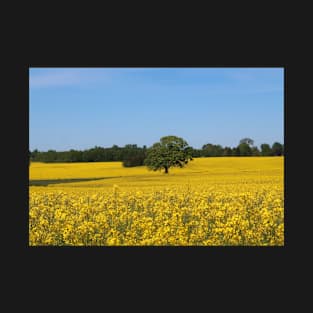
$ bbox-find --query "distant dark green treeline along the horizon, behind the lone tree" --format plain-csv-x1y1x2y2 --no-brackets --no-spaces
29,138,284,167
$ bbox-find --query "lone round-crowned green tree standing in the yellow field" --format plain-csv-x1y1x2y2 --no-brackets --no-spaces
144,136,192,174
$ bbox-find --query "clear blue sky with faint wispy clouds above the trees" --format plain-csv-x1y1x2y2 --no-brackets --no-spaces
29,68,284,151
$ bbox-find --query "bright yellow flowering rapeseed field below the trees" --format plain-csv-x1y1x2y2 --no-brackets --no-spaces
29,157,284,246
